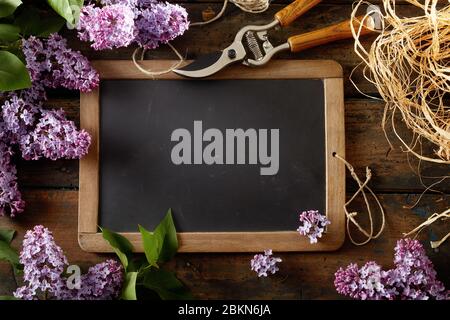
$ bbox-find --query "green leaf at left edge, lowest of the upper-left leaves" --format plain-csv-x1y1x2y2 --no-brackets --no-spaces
0,51,31,91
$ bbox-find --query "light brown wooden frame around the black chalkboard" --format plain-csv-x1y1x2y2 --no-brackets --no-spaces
78,60,345,252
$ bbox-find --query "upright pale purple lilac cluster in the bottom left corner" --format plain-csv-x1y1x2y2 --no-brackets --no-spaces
14,226,68,300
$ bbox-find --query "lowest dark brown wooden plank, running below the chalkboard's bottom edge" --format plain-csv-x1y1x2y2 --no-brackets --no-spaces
0,190,450,299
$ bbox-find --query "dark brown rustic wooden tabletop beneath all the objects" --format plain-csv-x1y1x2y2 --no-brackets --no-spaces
0,0,450,299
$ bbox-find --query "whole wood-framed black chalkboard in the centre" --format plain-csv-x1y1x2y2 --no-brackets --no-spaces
79,61,344,251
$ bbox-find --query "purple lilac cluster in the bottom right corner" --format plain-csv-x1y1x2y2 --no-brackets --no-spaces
334,239,450,300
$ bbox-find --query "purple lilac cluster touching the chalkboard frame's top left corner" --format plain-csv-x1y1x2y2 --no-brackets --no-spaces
22,33,99,92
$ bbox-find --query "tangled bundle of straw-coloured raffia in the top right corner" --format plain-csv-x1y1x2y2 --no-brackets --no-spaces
352,0,450,164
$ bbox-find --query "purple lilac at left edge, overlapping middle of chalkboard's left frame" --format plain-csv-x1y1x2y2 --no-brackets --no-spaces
0,90,91,217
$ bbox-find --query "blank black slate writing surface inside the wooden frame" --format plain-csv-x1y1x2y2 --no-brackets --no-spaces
99,79,326,232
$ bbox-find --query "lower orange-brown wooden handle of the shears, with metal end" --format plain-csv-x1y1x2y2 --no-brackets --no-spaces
288,16,374,52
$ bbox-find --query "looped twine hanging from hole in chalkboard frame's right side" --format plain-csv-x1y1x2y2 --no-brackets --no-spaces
334,153,385,246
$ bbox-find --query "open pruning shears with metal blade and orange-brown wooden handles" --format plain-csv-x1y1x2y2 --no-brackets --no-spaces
174,0,376,78
